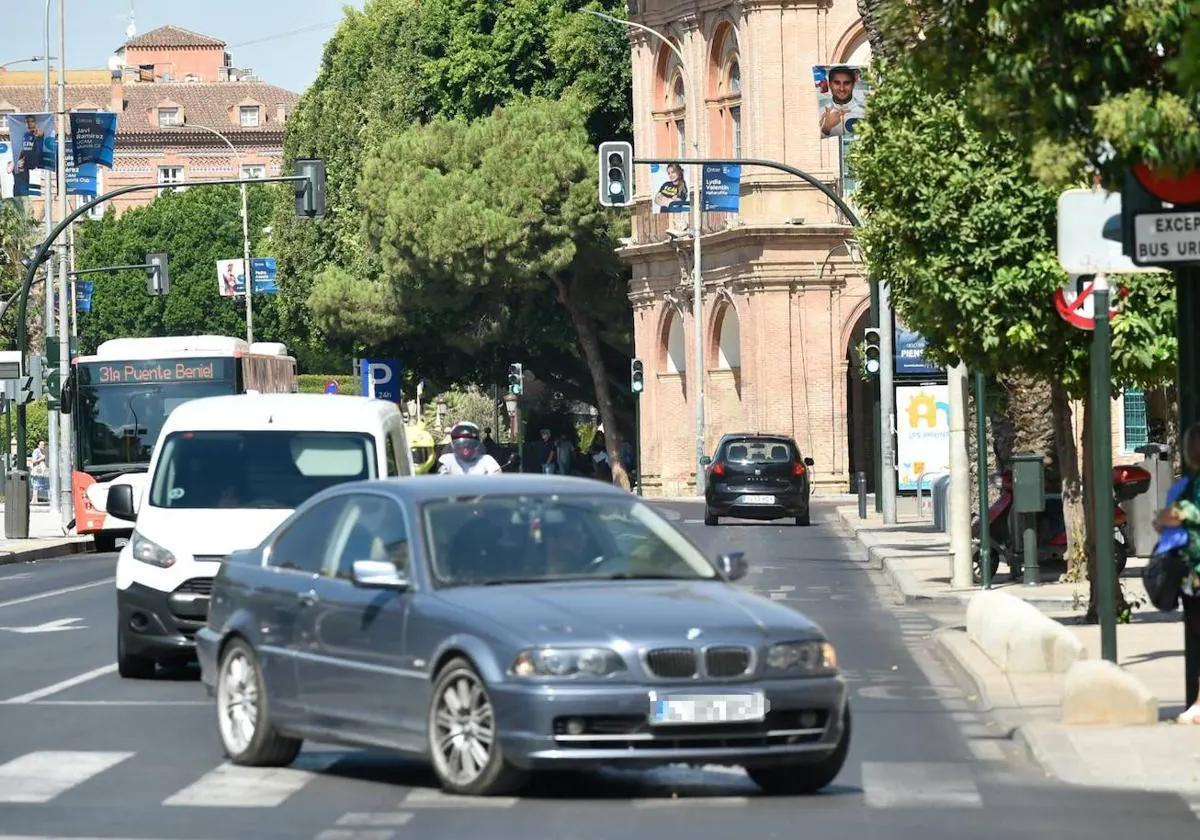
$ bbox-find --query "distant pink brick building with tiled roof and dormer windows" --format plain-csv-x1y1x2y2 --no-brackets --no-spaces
0,26,299,218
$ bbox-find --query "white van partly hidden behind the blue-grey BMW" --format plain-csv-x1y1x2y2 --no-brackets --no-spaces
106,394,413,679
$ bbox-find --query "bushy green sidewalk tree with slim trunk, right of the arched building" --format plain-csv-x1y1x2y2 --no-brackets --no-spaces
854,60,1175,609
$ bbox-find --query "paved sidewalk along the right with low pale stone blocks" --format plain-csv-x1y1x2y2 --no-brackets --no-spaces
838,508,1200,800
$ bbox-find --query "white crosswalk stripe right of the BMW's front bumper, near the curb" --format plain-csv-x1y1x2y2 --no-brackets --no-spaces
863,761,983,808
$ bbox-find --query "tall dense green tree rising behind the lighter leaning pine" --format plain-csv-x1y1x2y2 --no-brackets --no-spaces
267,0,632,396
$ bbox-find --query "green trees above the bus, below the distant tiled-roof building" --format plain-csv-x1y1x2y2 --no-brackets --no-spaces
77,185,280,350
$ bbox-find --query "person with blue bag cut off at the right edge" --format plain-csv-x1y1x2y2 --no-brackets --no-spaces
1142,424,1200,724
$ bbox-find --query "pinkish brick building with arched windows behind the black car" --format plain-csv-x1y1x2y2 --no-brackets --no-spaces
619,0,875,494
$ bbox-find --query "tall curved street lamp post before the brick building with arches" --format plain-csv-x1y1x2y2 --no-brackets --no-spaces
581,8,708,496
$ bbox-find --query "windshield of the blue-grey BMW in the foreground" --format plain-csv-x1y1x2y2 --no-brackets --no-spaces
422,494,719,586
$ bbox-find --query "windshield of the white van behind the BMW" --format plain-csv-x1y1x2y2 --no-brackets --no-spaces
150,431,377,510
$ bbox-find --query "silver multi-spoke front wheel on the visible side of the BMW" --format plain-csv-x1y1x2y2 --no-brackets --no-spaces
428,659,527,796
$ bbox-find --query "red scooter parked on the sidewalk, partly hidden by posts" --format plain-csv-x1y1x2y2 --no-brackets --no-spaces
971,464,1151,578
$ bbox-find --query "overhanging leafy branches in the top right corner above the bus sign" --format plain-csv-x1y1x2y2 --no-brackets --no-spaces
876,0,1200,185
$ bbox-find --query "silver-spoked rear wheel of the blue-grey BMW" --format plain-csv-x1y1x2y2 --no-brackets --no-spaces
217,638,304,767
